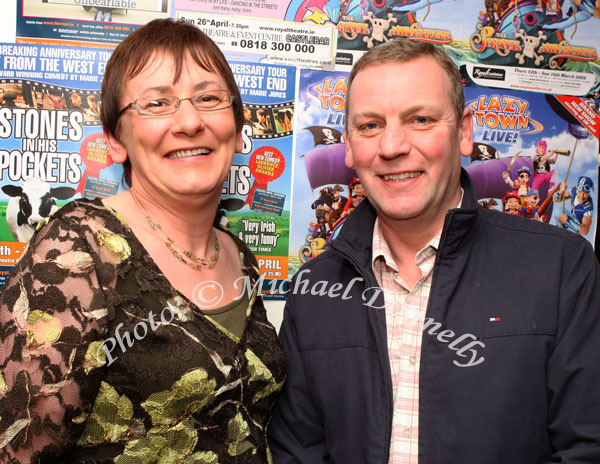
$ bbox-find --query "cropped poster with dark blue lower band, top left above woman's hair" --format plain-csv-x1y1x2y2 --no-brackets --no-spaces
17,0,171,48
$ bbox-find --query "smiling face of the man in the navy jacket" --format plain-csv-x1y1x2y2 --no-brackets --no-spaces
346,57,473,227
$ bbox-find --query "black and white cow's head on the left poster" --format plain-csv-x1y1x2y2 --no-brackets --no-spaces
2,178,75,242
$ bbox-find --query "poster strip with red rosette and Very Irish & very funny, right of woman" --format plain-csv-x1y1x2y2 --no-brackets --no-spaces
227,62,296,298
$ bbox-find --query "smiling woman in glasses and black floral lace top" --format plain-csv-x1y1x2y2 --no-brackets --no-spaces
0,19,286,463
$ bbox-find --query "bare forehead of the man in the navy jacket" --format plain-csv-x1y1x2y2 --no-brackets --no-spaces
349,56,452,111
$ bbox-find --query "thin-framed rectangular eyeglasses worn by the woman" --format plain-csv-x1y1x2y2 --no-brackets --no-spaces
119,90,234,116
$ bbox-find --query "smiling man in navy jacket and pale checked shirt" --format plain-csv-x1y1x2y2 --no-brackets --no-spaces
269,39,600,464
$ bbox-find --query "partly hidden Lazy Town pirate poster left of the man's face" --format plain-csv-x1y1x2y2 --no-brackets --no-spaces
290,70,364,275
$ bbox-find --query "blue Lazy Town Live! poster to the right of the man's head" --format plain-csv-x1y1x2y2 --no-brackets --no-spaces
462,88,600,245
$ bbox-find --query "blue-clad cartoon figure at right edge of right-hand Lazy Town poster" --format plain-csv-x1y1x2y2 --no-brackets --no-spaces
558,176,594,235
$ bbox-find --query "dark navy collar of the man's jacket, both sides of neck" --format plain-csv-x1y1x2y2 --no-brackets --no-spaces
329,169,479,269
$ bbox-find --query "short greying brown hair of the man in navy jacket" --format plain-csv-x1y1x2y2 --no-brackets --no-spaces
346,39,465,127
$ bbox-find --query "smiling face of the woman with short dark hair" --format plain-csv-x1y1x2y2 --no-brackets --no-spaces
110,51,242,200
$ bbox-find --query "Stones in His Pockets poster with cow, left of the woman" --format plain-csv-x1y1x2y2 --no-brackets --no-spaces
0,44,122,288
